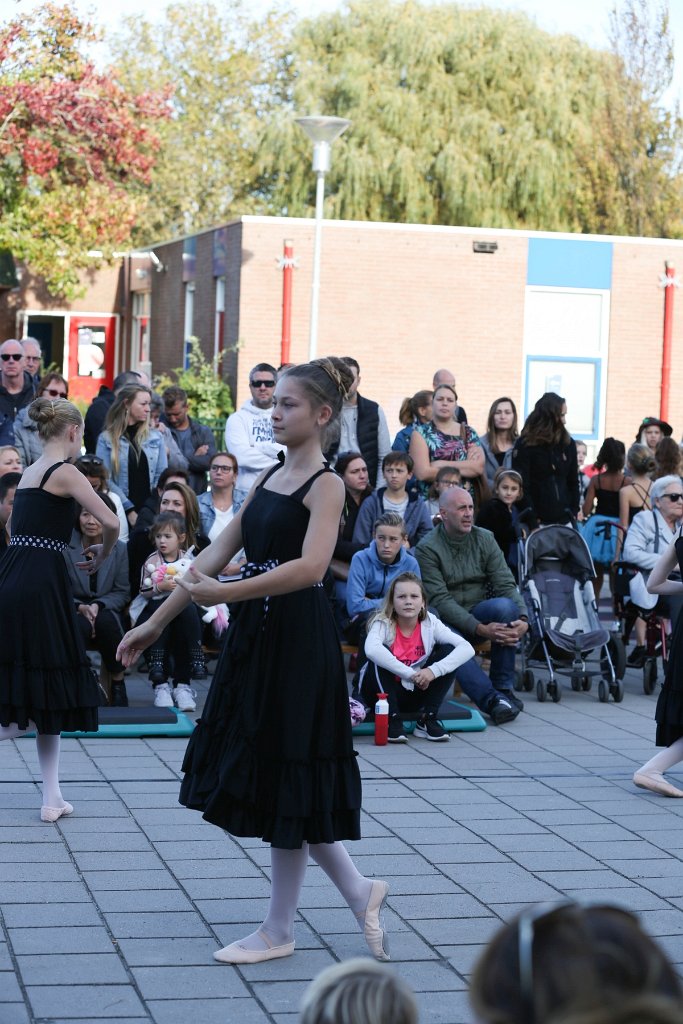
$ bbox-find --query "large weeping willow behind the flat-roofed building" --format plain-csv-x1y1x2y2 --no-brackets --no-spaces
259,0,676,231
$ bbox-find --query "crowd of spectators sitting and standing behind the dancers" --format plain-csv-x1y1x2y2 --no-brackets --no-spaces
0,338,683,729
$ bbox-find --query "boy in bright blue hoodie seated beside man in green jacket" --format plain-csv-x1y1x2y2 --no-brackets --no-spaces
346,512,420,632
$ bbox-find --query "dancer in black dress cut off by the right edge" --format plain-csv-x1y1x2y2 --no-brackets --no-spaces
633,530,683,797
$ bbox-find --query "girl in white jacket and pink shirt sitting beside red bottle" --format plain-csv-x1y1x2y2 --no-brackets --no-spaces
360,572,474,743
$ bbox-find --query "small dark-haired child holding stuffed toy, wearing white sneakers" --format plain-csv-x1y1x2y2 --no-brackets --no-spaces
137,512,202,711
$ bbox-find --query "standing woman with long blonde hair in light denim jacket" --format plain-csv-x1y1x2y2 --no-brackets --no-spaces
96,384,167,526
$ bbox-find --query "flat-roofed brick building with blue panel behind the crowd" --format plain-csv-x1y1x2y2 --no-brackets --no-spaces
0,217,683,444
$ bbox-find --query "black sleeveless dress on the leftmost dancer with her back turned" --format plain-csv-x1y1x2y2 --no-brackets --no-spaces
0,463,99,735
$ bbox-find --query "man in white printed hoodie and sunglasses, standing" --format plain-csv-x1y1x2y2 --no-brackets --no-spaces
225,362,285,490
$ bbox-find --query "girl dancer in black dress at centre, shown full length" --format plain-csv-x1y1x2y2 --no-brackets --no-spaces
119,359,389,964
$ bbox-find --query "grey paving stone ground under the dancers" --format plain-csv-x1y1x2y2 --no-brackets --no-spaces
0,655,683,1024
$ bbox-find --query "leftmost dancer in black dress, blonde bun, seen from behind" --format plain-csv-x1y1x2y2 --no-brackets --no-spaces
0,398,119,821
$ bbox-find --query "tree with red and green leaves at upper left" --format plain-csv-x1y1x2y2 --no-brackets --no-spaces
0,3,169,296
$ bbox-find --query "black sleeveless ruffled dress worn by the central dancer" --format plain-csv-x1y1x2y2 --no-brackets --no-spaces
180,466,361,850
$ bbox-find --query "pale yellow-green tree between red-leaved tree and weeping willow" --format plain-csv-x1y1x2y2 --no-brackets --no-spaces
109,0,288,243
